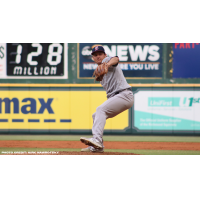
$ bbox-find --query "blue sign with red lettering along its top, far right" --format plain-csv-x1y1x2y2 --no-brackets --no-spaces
173,43,200,78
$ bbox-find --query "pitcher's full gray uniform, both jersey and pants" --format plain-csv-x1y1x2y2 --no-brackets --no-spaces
92,57,134,144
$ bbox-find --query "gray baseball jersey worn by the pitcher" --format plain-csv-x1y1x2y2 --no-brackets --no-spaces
101,57,131,98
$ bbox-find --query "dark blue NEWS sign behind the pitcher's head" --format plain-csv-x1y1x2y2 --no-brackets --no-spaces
78,43,162,78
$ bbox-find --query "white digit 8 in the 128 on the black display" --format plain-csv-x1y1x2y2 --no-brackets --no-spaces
47,44,63,65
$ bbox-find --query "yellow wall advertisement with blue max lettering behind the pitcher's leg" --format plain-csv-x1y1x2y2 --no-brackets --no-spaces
0,88,129,132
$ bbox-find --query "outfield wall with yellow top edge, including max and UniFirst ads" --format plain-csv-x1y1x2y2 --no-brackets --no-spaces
0,84,200,135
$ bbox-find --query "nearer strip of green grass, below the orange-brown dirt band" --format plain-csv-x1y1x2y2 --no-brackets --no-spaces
0,148,200,155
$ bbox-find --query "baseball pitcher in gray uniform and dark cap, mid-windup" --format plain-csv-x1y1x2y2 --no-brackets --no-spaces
80,46,134,152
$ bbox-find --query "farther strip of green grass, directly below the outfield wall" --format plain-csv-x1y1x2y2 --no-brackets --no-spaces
0,135,200,142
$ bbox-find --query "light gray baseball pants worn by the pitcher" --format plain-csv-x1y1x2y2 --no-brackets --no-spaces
92,90,134,144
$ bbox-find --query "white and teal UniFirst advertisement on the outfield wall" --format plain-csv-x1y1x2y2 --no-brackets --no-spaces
133,90,200,132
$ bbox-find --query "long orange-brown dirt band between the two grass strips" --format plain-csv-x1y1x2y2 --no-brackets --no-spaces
0,140,200,150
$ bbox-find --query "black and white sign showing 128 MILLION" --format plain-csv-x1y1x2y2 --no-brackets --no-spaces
0,43,68,79
